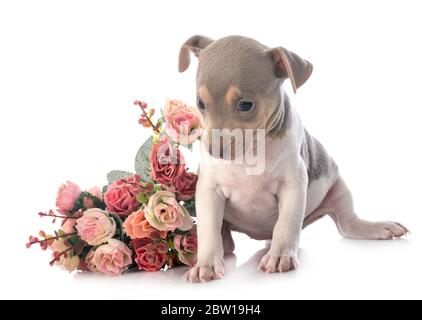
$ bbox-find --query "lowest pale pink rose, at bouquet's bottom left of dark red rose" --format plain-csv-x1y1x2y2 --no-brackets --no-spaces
92,239,132,276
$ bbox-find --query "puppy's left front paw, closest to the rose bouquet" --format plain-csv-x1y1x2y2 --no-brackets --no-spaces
184,257,224,283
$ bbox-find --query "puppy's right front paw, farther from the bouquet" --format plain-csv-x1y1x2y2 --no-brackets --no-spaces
259,249,299,273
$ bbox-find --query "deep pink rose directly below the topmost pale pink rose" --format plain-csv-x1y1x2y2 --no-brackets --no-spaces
150,137,185,184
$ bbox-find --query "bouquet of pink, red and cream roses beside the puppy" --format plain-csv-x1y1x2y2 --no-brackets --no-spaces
27,100,203,276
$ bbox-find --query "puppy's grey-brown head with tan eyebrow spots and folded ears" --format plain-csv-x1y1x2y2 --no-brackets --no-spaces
179,35,312,157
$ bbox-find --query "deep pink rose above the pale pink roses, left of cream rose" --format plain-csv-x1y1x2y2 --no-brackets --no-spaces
104,175,144,217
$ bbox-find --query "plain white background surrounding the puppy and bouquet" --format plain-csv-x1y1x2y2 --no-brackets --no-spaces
0,0,422,299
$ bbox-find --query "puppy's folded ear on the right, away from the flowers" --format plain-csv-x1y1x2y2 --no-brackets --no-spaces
268,47,313,93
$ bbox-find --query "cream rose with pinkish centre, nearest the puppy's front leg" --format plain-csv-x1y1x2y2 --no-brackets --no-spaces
145,191,193,231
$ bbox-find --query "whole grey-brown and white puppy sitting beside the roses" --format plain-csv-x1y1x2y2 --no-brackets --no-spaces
179,35,408,282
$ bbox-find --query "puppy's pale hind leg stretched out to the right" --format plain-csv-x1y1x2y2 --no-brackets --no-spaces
314,177,409,240
